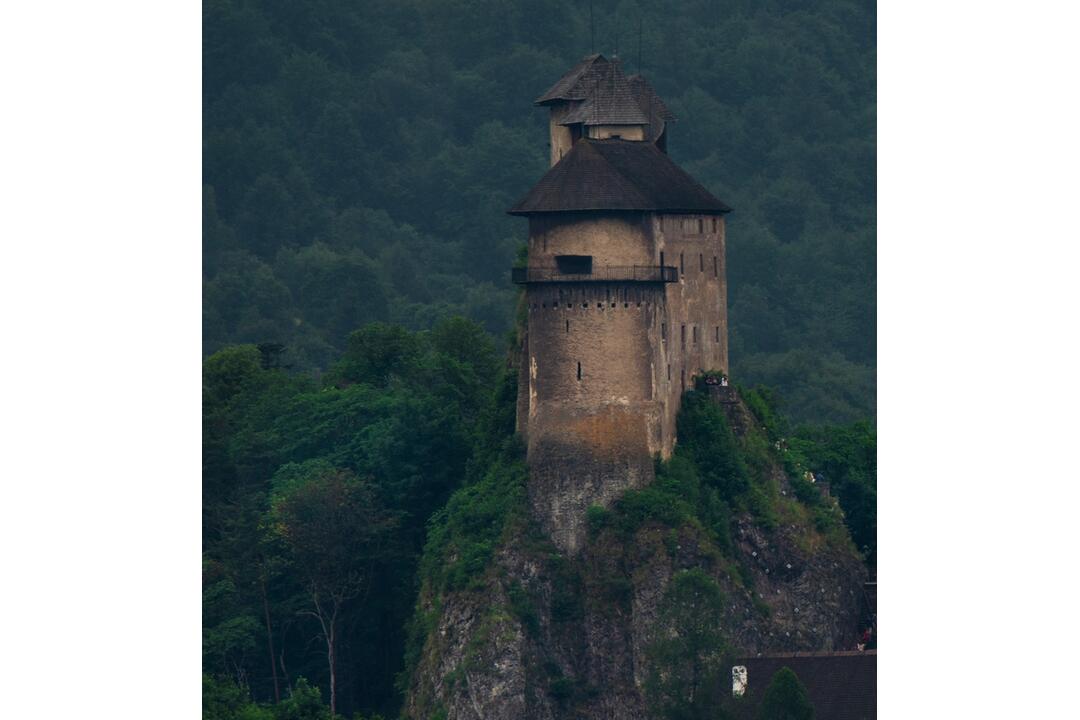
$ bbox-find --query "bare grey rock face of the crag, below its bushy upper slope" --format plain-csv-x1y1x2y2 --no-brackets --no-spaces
405,395,866,720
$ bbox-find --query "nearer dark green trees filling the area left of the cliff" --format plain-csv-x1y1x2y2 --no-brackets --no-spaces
203,318,501,717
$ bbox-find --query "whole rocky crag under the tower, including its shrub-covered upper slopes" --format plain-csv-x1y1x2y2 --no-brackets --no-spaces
405,389,865,720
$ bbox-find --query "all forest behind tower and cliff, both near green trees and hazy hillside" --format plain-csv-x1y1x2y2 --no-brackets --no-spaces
202,0,876,720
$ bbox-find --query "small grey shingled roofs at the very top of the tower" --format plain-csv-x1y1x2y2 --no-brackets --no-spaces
536,54,675,127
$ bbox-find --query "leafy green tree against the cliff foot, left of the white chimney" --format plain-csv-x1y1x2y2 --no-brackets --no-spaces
646,568,730,720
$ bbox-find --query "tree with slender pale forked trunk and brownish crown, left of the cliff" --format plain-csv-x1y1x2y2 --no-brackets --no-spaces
271,461,396,717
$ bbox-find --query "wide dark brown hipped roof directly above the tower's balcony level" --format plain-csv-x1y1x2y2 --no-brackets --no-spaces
509,138,731,215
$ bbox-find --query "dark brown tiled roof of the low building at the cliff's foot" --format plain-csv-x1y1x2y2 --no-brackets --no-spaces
727,650,877,720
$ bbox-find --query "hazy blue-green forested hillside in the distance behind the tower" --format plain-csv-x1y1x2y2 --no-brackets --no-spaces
203,0,876,422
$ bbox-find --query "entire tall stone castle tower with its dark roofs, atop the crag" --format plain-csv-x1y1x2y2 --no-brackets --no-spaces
510,55,731,553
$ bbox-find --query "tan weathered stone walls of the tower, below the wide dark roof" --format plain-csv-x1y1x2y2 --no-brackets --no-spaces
517,213,727,552
